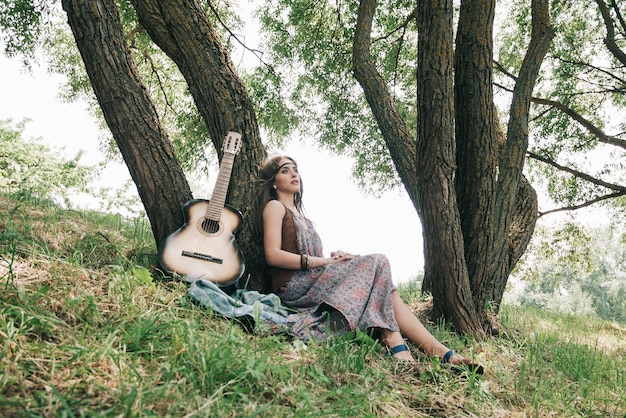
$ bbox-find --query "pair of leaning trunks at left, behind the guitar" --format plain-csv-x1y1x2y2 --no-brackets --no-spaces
63,0,265,292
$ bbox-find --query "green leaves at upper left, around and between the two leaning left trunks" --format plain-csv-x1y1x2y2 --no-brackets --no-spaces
0,0,251,175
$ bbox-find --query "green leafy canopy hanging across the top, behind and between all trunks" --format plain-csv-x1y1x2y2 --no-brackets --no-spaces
0,0,625,206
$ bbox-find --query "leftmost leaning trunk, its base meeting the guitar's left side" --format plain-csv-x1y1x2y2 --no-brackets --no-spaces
62,0,191,248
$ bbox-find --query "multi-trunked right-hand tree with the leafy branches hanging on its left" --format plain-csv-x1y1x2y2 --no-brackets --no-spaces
251,0,553,335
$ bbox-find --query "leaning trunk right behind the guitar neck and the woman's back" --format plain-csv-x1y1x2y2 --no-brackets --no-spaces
132,0,266,290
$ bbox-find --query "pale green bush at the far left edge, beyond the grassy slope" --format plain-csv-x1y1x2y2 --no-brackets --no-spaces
0,119,93,206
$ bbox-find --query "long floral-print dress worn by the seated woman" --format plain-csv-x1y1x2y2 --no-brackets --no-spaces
276,211,399,341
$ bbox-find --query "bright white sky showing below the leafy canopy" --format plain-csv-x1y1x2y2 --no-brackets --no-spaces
0,56,424,283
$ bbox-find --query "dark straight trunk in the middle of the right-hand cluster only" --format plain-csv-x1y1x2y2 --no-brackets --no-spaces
454,0,500,323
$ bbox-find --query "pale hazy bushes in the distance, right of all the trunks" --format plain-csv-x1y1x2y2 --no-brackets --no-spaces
516,222,626,324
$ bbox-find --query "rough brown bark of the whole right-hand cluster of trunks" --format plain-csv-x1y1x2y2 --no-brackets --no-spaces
353,0,550,336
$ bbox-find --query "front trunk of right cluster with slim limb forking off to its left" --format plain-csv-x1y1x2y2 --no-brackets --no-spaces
353,0,482,336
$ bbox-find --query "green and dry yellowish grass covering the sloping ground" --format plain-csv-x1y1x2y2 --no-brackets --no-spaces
0,196,626,417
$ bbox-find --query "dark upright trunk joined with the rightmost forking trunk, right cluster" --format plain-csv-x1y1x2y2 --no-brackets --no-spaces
455,0,552,329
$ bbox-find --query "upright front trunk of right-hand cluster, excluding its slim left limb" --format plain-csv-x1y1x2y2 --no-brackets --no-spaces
416,0,483,337
